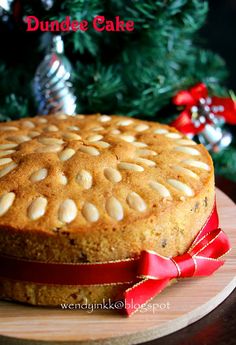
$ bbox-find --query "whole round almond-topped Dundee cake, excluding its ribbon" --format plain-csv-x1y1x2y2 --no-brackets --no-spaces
0,114,215,305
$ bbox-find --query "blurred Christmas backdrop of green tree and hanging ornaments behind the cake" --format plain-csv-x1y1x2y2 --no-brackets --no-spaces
0,0,236,180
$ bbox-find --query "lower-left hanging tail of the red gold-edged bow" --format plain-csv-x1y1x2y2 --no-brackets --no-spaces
124,278,170,316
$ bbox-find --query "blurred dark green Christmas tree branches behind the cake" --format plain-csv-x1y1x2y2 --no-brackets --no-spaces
0,0,236,178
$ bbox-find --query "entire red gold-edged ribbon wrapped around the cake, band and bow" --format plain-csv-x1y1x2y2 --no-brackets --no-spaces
0,206,230,315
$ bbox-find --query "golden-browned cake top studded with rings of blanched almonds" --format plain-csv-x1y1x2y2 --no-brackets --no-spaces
0,114,213,231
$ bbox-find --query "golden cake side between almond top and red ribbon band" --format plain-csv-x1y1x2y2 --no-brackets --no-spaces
0,178,214,263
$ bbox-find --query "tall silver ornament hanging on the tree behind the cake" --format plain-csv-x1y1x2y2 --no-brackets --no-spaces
33,35,76,115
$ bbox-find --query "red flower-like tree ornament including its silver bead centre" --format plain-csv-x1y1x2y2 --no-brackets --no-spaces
171,83,236,135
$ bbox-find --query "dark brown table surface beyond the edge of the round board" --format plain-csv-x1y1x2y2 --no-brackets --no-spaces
143,177,236,345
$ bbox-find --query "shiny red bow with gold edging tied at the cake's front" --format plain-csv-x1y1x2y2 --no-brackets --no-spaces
125,229,230,315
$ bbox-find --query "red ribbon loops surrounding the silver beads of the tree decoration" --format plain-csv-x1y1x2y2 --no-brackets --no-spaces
171,83,236,135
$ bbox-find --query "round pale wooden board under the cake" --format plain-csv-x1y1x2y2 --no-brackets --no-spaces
0,190,236,345
